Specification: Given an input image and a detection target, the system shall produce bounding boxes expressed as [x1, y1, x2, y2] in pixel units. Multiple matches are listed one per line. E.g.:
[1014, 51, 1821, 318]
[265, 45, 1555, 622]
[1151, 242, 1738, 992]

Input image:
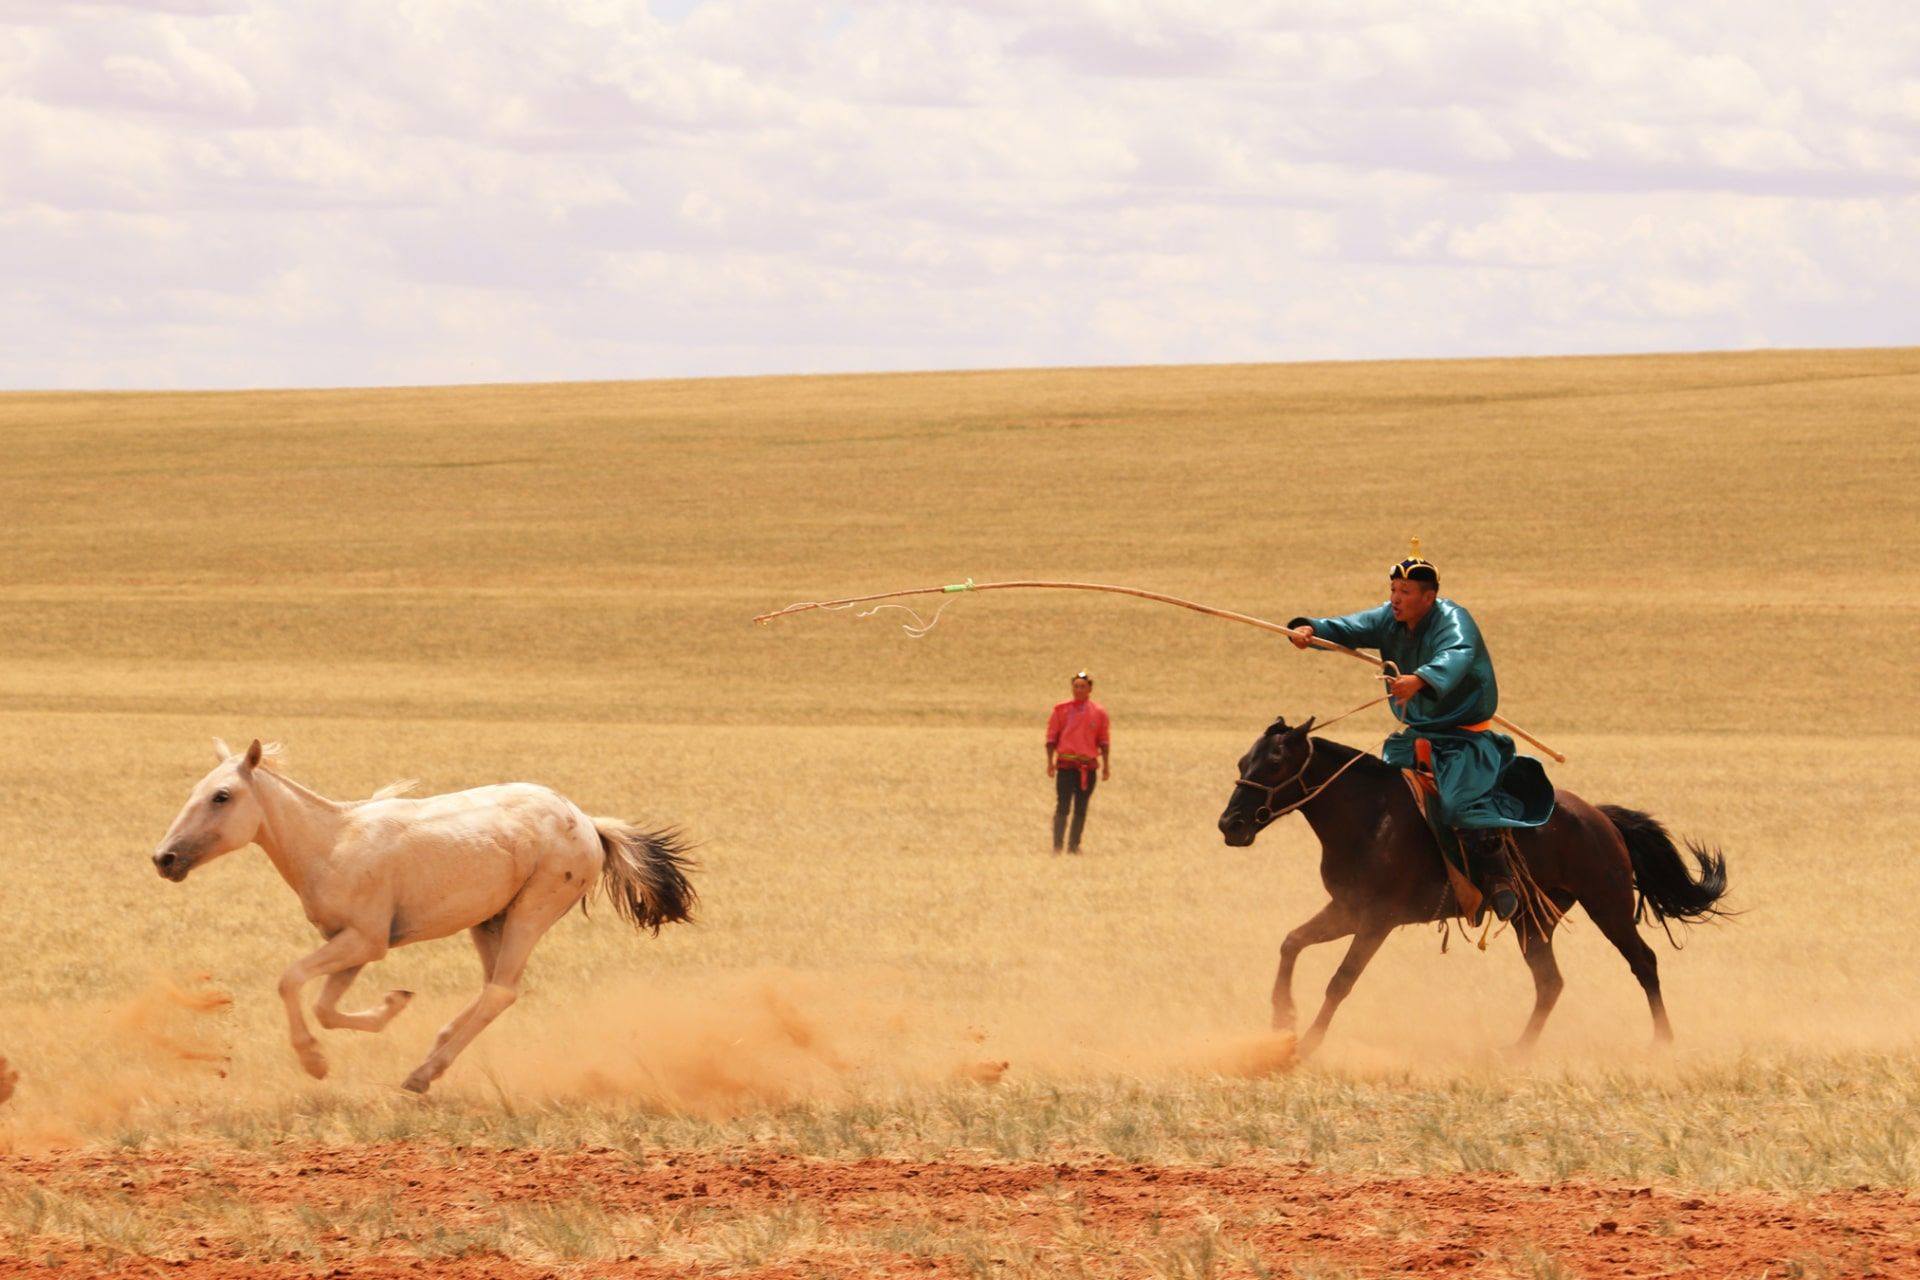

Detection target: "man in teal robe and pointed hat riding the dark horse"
[1286, 537, 1553, 923]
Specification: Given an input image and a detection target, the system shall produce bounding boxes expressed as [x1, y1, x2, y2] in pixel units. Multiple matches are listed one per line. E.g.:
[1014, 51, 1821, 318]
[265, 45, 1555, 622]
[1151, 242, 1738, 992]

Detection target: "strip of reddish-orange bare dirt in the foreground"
[0, 1144, 1920, 1280]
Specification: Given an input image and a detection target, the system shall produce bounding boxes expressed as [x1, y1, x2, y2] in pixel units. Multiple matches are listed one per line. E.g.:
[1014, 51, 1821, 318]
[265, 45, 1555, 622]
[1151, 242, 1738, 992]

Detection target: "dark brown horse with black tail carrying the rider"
[1219, 720, 1728, 1057]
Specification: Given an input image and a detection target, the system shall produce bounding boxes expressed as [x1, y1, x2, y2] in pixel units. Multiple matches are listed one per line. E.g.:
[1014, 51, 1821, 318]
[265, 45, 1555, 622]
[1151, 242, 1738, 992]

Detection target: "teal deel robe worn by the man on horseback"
[1286, 597, 1553, 827]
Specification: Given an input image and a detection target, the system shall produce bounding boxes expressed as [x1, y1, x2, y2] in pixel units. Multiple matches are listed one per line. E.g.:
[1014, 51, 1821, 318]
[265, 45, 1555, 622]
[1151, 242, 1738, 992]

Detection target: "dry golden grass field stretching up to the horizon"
[0, 349, 1920, 1274]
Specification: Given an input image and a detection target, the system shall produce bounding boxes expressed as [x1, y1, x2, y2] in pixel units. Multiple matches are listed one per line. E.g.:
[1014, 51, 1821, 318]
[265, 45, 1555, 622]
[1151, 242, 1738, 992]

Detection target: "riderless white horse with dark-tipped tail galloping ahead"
[154, 739, 695, 1094]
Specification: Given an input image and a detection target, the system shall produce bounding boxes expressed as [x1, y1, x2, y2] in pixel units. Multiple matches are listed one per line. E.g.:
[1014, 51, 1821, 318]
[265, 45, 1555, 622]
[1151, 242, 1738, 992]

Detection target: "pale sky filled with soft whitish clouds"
[0, 0, 1920, 390]
